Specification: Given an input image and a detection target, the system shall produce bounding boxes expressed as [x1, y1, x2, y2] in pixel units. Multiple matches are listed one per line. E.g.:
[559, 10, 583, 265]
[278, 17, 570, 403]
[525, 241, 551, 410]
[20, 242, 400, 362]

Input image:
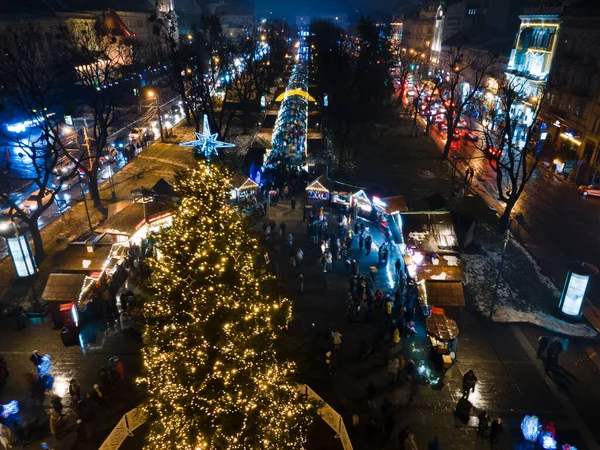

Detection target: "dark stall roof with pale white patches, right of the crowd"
[401, 211, 458, 253]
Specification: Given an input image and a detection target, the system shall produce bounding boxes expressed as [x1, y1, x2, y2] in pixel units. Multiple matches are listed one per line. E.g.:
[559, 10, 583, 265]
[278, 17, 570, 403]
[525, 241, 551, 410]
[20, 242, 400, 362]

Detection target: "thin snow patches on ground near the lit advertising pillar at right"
[462, 250, 596, 338]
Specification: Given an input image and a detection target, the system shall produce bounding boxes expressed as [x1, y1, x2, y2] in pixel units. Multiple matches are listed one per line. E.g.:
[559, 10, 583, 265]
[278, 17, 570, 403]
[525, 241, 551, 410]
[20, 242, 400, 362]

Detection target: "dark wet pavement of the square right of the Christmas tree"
[260, 203, 586, 450]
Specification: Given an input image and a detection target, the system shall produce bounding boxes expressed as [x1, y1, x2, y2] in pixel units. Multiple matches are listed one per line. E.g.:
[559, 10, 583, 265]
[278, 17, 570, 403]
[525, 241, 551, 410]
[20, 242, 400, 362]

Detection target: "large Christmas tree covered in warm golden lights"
[140, 165, 311, 450]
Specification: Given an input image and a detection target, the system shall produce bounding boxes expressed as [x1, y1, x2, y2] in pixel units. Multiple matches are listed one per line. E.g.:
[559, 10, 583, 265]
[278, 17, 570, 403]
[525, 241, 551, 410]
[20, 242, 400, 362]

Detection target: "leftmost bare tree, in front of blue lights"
[0, 25, 70, 263]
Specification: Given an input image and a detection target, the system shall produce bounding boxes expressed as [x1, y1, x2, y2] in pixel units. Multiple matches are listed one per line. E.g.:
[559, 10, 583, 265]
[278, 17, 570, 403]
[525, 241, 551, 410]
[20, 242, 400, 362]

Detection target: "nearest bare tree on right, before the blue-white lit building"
[476, 78, 548, 229]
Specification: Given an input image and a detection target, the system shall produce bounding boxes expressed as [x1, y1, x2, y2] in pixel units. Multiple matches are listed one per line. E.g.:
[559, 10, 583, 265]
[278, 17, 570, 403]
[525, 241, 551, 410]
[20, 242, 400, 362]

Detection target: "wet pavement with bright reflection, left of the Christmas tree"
[0, 317, 141, 450]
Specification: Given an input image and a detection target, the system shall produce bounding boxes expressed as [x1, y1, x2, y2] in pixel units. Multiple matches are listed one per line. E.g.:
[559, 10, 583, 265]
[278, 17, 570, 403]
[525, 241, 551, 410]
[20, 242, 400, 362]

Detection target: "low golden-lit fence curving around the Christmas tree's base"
[98, 384, 353, 450]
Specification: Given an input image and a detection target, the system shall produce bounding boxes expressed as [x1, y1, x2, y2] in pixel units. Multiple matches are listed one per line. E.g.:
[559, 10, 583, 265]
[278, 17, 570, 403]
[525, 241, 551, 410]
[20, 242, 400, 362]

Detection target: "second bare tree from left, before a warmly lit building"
[63, 21, 132, 215]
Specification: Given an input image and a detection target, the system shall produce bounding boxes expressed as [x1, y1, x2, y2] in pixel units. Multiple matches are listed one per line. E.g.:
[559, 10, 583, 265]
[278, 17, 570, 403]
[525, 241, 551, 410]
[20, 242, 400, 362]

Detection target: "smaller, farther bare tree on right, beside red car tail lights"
[439, 47, 497, 159]
